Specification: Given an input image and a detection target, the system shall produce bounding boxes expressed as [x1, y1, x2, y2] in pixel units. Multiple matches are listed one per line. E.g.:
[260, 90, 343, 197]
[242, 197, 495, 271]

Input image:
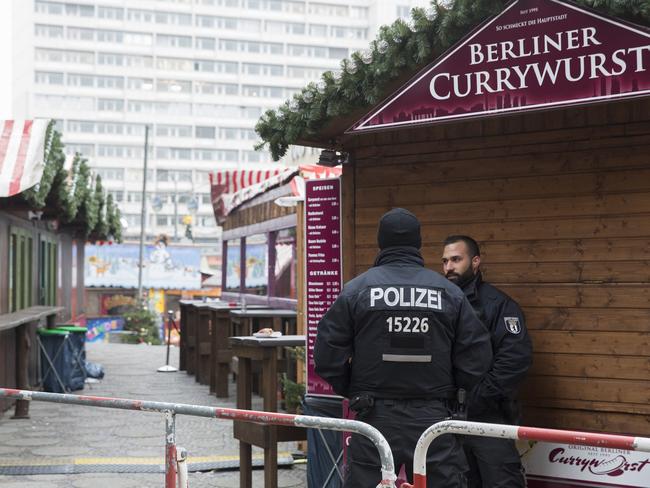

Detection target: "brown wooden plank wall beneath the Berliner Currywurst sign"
[350, 102, 650, 435]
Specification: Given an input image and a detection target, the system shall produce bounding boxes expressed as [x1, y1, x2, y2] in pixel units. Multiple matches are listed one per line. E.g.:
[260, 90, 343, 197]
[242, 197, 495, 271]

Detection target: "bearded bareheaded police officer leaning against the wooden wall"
[442, 235, 532, 488]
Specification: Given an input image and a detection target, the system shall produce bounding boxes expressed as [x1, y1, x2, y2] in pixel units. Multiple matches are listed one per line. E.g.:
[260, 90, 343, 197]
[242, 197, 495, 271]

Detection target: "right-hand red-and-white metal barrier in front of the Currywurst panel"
[401, 420, 650, 488]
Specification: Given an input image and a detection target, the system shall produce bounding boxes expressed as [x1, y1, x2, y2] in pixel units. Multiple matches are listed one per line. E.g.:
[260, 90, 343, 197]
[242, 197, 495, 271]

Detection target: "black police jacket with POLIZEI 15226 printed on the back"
[314, 247, 492, 399]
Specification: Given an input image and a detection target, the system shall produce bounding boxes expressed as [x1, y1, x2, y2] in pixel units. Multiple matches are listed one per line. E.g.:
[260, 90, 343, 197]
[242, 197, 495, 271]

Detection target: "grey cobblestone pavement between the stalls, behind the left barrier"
[0, 343, 307, 488]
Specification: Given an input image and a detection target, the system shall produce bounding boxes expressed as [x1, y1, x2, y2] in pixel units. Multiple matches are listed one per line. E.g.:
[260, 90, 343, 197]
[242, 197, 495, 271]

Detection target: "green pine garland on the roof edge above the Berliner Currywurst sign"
[255, 0, 650, 161]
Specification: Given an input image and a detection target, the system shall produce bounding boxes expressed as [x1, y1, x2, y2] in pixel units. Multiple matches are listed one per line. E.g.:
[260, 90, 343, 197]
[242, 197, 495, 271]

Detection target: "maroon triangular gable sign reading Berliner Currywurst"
[349, 0, 650, 132]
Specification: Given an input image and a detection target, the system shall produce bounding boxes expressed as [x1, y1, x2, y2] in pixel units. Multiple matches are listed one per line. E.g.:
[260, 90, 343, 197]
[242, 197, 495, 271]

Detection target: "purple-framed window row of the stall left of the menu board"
[223, 227, 297, 300]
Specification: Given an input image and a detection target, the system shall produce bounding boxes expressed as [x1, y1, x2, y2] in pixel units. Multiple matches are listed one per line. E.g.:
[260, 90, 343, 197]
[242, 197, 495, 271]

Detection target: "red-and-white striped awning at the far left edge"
[0, 119, 48, 198]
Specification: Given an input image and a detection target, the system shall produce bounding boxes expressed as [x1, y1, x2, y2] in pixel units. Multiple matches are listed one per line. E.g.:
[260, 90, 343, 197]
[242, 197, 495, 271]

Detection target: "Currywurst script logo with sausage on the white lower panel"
[548, 446, 650, 477]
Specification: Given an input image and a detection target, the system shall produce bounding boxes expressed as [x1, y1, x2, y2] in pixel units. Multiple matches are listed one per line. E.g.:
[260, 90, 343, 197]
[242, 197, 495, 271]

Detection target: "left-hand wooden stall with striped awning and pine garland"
[0, 120, 120, 417]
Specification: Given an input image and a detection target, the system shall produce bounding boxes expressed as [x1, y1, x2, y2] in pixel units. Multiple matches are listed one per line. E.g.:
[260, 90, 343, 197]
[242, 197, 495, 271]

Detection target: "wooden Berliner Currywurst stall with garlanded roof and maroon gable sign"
[258, 0, 650, 435]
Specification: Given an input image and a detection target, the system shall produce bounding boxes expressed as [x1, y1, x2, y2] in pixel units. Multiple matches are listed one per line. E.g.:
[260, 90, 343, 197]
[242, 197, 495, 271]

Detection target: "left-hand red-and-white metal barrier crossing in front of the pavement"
[0, 388, 397, 488]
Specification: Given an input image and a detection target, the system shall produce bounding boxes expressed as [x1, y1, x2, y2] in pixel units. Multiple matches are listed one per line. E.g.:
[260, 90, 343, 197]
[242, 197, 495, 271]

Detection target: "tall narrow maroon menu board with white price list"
[305, 178, 342, 396]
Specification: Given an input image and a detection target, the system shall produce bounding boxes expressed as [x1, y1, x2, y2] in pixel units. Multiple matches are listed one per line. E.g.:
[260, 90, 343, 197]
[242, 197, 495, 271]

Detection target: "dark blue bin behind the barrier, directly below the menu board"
[303, 395, 343, 488]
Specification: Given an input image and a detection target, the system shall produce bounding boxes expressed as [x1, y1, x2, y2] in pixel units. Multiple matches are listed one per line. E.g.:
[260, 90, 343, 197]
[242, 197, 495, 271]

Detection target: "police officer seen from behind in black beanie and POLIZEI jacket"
[314, 208, 492, 488]
